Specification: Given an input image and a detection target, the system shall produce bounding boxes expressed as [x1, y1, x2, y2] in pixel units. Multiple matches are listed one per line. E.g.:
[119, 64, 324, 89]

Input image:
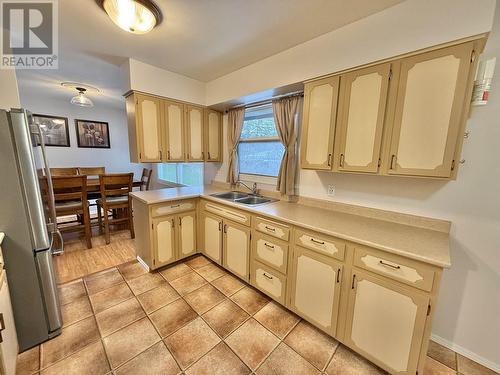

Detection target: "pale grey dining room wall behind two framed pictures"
[19, 86, 146, 179]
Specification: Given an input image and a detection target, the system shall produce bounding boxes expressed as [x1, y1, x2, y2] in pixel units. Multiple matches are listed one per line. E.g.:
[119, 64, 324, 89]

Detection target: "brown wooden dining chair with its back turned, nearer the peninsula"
[97, 173, 135, 244]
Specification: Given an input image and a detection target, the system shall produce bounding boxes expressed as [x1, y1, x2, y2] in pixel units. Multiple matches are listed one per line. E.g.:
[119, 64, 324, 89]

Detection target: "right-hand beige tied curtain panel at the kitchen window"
[273, 96, 301, 196]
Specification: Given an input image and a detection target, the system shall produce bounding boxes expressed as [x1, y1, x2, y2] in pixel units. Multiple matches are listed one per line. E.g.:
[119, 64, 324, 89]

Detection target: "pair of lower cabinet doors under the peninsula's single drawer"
[152, 211, 196, 268]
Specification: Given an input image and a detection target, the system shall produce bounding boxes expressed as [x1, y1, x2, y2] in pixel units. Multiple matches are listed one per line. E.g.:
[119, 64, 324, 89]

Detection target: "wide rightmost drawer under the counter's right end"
[354, 247, 436, 291]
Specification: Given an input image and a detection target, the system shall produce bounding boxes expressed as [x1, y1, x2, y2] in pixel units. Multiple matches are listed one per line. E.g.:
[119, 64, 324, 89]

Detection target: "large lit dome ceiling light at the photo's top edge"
[96, 0, 163, 34]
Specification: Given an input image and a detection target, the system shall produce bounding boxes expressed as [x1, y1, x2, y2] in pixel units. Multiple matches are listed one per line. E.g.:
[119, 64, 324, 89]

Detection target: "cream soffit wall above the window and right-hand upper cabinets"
[206, 0, 495, 105]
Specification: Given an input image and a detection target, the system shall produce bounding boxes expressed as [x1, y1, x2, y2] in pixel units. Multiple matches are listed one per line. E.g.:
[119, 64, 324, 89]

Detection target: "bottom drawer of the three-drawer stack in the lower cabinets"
[251, 261, 286, 304]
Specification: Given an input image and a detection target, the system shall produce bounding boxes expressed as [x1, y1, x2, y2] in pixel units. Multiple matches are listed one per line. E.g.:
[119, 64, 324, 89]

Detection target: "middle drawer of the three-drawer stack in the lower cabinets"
[252, 232, 288, 275]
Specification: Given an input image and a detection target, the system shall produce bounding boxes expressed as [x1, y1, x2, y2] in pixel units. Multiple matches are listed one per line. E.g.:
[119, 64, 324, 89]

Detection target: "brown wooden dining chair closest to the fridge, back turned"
[52, 175, 92, 249]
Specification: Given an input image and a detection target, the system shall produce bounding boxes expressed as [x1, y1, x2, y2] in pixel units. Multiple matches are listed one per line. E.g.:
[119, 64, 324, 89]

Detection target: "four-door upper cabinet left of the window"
[126, 92, 222, 163]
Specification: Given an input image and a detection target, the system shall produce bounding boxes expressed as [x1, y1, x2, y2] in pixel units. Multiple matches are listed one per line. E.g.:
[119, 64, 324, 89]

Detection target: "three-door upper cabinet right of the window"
[301, 39, 484, 178]
